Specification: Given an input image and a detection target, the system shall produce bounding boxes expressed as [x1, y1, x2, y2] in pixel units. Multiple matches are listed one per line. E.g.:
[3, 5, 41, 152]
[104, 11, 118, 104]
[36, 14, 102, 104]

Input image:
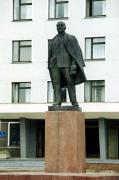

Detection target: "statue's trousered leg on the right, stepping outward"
[62, 68, 78, 106]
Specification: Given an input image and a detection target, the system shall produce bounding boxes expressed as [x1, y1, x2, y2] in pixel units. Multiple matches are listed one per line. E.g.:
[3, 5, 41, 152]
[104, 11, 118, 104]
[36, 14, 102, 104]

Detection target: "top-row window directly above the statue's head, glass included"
[49, 0, 68, 18]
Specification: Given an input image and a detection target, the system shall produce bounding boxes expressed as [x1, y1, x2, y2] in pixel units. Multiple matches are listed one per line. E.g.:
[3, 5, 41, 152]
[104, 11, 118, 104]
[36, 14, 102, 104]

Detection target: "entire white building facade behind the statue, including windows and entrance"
[0, 0, 119, 163]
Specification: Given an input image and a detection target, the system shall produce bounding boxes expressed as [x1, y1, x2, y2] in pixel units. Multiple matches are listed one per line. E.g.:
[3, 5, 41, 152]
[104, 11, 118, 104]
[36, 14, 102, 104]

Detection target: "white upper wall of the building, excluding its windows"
[0, 0, 119, 106]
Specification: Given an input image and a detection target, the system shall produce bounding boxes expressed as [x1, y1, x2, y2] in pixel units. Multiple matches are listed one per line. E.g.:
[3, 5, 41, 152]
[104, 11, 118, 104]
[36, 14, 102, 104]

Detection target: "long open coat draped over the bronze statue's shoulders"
[48, 33, 86, 87]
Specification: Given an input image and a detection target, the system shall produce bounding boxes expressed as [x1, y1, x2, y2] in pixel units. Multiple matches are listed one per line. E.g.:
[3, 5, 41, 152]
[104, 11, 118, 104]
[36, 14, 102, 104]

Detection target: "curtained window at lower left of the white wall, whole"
[12, 82, 31, 103]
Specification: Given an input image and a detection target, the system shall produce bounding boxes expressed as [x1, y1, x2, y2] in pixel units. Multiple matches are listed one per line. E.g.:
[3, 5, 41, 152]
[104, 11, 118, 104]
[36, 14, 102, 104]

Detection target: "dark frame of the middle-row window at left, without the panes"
[12, 40, 32, 64]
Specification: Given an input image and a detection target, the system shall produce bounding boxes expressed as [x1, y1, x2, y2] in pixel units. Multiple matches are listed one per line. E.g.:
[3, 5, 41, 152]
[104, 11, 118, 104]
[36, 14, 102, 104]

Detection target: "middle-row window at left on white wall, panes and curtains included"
[12, 41, 31, 63]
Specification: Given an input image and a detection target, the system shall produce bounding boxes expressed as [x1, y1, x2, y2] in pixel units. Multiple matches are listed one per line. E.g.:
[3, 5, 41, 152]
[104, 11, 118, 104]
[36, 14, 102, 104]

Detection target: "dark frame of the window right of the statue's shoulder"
[85, 36, 106, 61]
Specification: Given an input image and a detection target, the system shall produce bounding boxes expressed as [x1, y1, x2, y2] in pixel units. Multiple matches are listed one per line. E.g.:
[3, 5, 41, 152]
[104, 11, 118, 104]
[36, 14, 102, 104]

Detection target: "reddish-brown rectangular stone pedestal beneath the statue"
[45, 111, 85, 173]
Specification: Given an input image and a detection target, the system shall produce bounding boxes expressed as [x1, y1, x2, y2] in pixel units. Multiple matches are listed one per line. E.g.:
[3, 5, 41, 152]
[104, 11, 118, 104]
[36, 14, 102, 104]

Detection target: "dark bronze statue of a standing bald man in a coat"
[48, 21, 86, 106]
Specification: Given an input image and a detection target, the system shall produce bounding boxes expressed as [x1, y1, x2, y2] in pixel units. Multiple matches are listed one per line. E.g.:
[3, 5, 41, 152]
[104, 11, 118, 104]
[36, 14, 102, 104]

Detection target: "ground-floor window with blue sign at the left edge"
[0, 119, 20, 159]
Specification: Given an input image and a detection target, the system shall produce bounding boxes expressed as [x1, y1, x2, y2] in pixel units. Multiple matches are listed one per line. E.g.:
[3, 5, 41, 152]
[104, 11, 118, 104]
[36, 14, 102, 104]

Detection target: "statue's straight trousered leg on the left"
[52, 67, 61, 105]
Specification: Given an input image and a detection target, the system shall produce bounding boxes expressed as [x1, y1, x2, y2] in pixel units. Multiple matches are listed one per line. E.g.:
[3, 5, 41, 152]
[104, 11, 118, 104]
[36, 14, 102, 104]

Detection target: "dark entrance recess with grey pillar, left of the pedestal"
[20, 119, 45, 158]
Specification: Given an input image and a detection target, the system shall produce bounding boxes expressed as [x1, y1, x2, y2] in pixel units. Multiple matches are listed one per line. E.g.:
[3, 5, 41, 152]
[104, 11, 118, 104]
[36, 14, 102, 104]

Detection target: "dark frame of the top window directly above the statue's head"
[48, 0, 69, 20]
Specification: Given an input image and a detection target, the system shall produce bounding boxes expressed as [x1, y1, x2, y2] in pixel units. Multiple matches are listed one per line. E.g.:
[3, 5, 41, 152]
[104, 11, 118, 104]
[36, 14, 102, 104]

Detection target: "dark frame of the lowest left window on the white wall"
[12, 81, 31, 104]
